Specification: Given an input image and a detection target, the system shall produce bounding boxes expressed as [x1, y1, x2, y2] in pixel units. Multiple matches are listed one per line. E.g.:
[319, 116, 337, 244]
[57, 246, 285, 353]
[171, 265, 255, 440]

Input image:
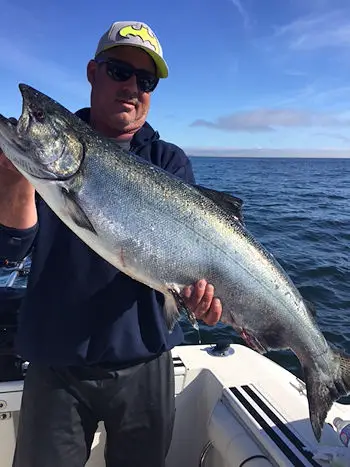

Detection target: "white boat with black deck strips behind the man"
[0, 266, 350, 467]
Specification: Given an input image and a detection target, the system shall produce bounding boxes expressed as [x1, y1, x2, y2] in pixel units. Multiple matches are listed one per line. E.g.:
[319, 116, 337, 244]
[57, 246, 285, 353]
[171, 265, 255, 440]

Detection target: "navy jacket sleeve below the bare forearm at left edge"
[0, 223, 38, 261]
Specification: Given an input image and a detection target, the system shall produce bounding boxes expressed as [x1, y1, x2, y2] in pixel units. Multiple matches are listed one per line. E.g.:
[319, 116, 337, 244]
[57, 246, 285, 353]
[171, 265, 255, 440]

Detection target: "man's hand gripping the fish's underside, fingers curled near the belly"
[182, 279, 222, 326]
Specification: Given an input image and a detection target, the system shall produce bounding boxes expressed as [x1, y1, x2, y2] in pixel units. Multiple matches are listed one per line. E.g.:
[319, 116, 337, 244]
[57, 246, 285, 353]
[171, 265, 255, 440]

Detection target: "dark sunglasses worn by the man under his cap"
[95, 57, 159, 92]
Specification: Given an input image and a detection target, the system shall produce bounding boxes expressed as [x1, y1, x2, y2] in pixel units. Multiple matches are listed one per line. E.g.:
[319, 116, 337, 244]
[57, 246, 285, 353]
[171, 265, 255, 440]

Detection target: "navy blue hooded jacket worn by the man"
[0, 109, 194, 368]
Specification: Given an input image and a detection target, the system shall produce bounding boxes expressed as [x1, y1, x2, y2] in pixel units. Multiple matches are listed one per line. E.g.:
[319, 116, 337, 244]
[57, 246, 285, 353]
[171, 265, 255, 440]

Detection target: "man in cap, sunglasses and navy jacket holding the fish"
[0, 22, 221, 467]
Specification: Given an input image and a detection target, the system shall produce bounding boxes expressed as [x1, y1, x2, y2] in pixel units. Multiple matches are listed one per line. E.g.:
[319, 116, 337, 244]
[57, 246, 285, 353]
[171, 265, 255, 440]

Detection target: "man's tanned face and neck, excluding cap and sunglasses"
[87, 46, 156, 139]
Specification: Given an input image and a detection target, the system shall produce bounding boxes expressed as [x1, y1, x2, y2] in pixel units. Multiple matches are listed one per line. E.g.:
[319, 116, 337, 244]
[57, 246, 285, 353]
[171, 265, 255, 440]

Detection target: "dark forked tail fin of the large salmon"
[303, 349, 350, 441]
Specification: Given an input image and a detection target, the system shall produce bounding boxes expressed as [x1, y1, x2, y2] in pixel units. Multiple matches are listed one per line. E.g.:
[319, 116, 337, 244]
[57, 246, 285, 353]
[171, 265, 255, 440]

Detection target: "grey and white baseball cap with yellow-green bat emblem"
[95, 21, 168, 78]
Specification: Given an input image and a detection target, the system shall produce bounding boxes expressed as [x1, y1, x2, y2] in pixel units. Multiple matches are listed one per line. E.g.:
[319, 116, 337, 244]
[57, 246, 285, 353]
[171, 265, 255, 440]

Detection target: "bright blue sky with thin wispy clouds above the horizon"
[0, 0, 350, 155]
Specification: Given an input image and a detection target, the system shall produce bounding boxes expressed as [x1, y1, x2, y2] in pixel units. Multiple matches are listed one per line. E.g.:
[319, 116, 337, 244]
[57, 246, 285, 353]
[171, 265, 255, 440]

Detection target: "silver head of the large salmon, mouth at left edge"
[0, 84, 84, 180]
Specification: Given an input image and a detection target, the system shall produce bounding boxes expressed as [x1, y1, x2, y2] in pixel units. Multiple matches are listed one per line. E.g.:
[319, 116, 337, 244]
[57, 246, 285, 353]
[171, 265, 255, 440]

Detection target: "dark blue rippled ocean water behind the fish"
[181, 157, 350, 376]
